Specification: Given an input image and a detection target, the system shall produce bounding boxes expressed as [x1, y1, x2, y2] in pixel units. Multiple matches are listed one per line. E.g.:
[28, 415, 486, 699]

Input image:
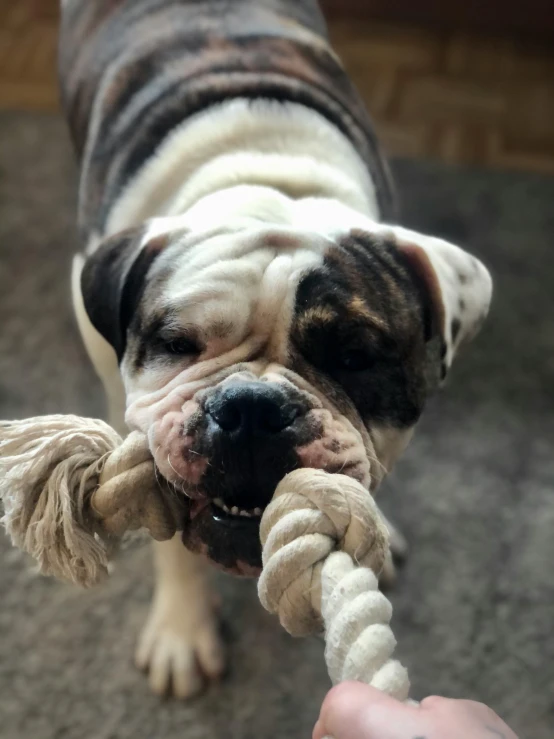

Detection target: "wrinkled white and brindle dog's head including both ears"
[82, 219, 491, 574]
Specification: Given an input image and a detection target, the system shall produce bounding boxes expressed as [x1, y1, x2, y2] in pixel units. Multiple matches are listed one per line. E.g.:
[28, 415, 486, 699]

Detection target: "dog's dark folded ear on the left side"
[81, 226, 168, 362]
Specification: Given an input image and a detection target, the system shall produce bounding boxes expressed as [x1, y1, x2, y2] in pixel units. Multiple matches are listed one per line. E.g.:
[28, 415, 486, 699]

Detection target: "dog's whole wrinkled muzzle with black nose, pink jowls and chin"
[145, 371, 372, 576]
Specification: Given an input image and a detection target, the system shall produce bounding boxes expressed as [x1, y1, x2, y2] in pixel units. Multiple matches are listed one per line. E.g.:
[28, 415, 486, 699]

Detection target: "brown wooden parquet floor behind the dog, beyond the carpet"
[0, 0, 554, 173]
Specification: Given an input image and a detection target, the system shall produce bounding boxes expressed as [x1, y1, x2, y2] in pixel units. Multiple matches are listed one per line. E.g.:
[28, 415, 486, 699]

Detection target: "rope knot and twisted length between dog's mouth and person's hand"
[258, 469, 409, 700]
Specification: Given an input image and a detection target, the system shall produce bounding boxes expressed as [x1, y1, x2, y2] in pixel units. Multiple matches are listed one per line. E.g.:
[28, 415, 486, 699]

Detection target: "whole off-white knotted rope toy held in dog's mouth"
[0, 415, 410, 700]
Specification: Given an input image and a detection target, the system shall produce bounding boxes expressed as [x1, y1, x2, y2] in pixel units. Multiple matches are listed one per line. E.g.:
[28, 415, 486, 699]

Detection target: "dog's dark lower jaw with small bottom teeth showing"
[182, 498, 264, 577]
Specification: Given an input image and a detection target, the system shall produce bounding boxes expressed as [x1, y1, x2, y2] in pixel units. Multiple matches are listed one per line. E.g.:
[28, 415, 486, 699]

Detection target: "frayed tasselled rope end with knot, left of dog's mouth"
[0, 415, 176, 587]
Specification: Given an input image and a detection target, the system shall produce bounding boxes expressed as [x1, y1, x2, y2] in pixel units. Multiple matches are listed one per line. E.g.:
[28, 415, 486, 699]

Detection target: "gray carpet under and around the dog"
[0, 114, 554, 739]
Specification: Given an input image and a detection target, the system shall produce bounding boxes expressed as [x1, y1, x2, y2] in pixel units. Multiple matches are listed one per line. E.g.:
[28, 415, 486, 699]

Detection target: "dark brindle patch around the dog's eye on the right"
[291, 232, 426, 428]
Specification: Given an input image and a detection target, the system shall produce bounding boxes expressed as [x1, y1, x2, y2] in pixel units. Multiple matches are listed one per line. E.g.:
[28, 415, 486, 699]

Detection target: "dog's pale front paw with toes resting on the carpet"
[135, 597, 225, 700]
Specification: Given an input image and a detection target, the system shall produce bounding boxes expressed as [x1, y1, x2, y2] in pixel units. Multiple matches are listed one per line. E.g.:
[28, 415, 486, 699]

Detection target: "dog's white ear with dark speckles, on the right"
[388, 226, 492, 379]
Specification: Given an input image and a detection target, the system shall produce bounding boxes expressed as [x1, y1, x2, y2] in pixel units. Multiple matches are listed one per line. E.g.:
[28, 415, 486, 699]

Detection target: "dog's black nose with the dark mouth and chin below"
[183, 380, 309, 574]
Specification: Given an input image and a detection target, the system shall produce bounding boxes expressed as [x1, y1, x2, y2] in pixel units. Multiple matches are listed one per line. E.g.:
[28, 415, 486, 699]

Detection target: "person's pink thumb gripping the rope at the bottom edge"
[313, 682, 425, 739]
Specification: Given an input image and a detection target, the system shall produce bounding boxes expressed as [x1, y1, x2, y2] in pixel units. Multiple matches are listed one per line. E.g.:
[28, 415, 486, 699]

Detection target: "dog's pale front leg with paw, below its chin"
[136, 534, 225, 698]
